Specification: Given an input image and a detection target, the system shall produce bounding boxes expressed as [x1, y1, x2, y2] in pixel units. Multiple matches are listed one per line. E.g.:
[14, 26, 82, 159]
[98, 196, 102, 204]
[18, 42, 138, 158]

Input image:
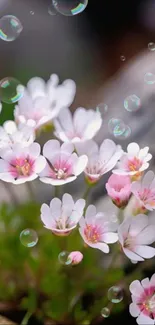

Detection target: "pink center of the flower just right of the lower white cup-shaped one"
[84, 224, 101, 244]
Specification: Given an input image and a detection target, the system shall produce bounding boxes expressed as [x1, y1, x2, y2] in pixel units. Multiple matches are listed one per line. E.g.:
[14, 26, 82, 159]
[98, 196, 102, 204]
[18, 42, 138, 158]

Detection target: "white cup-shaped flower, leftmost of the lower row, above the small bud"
[41, 193, 85, 236]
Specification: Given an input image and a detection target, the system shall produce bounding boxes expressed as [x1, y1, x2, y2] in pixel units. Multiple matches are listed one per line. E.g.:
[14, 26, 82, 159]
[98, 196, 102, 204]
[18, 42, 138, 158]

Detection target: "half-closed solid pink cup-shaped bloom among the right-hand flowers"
[105, 174, 131, 208]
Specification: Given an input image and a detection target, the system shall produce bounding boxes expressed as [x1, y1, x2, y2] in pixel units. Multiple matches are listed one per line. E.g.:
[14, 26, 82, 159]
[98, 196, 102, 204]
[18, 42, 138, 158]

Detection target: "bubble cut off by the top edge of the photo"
[52, 0, 88, 16]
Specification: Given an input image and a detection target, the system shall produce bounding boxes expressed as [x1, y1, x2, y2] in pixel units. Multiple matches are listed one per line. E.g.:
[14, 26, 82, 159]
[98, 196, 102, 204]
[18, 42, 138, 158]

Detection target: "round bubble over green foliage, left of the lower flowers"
[20, 229, 38, 247]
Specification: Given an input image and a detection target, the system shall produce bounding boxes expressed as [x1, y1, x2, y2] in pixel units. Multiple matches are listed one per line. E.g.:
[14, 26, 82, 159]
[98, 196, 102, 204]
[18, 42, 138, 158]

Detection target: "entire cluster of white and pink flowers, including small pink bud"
[0, 75, 155, 324]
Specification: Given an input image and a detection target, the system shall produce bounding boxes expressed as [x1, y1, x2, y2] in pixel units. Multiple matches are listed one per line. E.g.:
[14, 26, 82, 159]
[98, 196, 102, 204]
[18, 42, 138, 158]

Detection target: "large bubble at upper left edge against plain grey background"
[0, 15, 23, 42]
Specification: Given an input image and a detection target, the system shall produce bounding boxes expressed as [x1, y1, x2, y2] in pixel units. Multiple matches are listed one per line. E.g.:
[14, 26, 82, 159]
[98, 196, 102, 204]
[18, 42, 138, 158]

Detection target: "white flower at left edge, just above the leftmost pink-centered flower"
[0, 121, 35, 149]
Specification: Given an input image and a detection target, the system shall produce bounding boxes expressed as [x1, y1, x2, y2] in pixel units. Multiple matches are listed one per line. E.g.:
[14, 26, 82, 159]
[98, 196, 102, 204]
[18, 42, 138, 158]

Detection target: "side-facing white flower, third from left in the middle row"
[75, 139, 123, 183]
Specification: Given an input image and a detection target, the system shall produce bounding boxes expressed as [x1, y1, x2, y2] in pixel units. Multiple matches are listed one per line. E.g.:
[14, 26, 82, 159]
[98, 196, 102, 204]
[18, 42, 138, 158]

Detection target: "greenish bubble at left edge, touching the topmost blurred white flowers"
[0, 77, 24, 104]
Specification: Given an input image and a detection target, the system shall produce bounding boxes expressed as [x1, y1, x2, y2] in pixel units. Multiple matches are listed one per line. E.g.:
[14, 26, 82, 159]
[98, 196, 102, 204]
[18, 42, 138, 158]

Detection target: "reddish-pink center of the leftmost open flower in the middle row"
[10, 158, 33, 178]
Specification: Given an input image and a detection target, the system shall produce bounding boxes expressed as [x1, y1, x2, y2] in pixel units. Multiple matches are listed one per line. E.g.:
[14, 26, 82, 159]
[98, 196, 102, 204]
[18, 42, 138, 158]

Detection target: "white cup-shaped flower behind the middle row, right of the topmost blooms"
[54, 107, 102, 143]
